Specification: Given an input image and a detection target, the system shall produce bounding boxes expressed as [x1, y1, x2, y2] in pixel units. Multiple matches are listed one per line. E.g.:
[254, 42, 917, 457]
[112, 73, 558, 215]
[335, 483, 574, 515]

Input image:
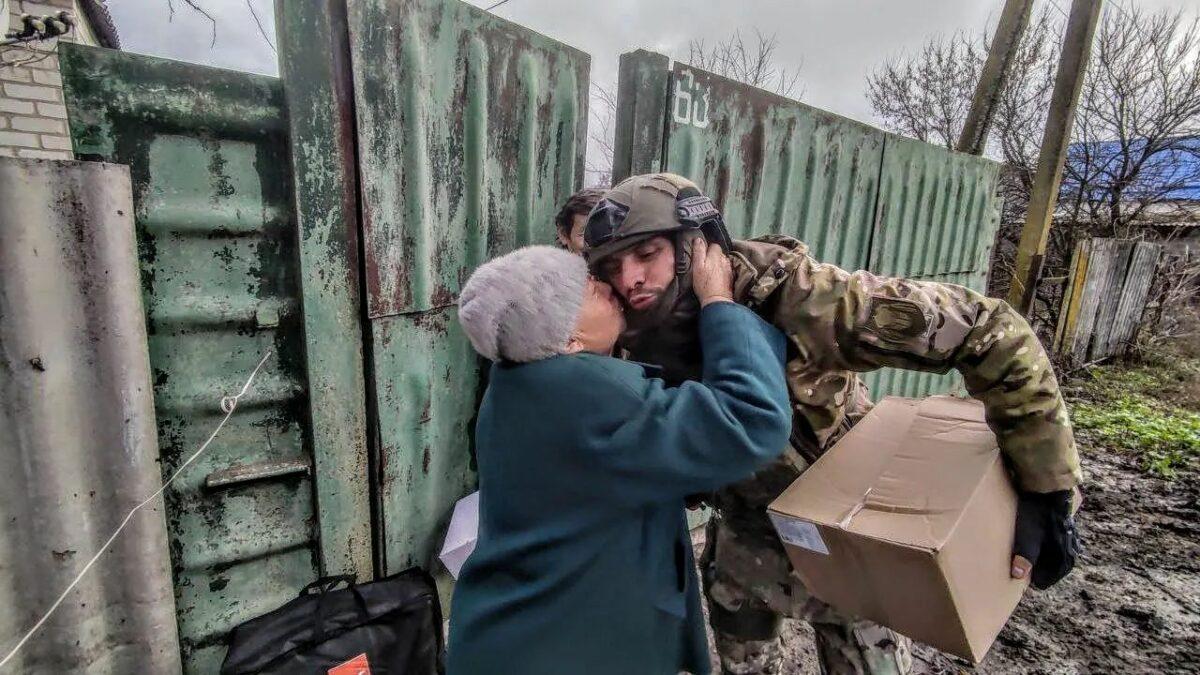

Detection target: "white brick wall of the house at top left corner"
[0, 0, 97, 160]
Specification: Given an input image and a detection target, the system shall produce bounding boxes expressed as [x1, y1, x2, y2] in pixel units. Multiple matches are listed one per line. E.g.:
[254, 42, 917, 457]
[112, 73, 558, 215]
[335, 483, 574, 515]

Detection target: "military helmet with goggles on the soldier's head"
[583, 173, 731, 267]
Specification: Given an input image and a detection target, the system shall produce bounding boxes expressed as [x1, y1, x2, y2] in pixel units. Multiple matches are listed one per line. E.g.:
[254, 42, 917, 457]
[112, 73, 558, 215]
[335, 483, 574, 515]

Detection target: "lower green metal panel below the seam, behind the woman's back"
[372, 307, 481, 573]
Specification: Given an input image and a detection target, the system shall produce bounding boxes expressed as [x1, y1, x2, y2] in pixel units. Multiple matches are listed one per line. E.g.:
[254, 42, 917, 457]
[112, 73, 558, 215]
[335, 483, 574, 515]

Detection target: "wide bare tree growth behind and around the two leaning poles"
[866, 5, 1200, 325]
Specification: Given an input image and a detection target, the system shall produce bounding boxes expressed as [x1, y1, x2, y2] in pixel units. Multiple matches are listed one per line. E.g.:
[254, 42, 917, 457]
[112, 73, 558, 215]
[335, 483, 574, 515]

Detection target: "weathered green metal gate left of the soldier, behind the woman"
[61, 0, 589, 673]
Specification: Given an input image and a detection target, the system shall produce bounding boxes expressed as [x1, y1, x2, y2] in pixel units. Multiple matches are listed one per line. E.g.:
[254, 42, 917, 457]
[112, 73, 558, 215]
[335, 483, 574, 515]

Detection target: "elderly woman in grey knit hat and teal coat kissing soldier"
[449, 240, 791, 675]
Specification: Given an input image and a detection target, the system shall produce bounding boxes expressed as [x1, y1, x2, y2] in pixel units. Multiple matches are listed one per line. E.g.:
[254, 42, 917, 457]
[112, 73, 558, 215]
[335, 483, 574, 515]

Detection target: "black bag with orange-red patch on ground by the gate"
[221, 567, 443, 675]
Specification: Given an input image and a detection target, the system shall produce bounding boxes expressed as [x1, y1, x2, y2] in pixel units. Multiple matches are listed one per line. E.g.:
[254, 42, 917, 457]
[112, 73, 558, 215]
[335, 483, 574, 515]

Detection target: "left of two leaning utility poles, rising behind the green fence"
[956, 0, 1033, 155]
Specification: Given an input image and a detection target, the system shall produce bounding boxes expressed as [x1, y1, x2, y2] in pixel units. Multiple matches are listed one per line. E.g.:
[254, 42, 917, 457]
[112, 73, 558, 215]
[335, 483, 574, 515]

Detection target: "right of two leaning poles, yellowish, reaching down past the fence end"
[1008, 0, 1103, 316]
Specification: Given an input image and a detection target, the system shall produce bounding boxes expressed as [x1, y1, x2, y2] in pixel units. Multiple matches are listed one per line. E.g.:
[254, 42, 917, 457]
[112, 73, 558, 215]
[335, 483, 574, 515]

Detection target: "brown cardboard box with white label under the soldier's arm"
[769, 396, 1027, 663]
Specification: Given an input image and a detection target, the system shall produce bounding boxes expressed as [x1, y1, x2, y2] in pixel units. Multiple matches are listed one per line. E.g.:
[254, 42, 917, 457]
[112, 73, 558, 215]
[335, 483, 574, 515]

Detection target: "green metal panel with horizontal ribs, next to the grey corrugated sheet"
[60, 44, 318, 674]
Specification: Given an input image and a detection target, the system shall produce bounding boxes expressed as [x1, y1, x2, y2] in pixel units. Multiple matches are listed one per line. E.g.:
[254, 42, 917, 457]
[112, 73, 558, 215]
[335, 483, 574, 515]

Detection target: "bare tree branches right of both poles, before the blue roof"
[1064, 8, 1200, 238]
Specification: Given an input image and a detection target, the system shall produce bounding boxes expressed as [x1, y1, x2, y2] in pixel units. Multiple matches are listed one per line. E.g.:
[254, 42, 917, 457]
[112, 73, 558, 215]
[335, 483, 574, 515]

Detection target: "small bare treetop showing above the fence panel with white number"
[688, 29, 804, 97]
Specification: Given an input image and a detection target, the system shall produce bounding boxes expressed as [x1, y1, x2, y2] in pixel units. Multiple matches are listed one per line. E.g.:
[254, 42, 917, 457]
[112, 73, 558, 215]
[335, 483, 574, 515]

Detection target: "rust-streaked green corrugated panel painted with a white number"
[665, 64, 884, 269]
